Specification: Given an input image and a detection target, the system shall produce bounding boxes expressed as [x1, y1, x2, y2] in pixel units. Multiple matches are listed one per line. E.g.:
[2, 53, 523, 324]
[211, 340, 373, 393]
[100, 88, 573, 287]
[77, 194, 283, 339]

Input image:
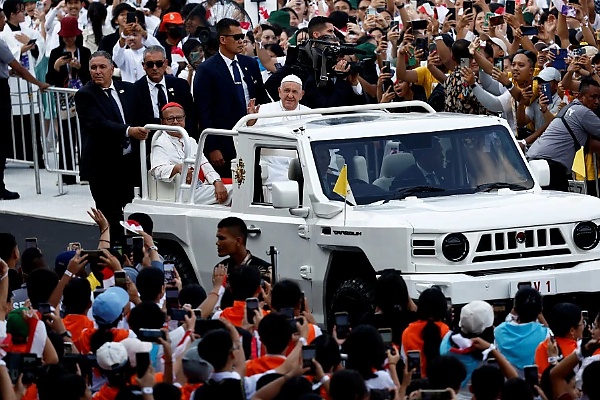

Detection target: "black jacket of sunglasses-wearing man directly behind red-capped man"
[133, 75, 198, 139]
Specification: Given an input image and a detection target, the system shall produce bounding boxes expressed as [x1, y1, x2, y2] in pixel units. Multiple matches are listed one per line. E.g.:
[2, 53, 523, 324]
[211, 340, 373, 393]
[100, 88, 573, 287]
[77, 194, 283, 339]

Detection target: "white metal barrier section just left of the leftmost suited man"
[39, 87, 81, 195]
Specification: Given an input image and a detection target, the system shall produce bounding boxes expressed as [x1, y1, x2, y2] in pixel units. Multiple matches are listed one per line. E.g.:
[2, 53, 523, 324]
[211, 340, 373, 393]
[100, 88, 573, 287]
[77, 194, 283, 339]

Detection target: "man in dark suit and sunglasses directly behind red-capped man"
[133, 46, 198, 138]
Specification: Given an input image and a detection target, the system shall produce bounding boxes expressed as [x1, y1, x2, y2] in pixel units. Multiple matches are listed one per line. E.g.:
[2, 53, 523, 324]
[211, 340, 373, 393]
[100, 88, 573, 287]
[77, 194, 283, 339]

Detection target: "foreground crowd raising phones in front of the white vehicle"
[0, 209, 600, 400]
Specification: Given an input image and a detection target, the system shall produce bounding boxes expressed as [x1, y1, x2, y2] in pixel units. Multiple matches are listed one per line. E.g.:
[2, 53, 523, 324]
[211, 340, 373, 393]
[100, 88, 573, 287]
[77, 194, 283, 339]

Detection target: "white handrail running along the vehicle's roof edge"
[232, 100, 436, 130]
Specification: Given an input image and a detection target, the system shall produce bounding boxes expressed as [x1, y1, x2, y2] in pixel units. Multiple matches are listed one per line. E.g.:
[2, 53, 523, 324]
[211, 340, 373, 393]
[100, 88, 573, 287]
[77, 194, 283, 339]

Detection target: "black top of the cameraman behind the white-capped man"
[300, 74, 367, 108]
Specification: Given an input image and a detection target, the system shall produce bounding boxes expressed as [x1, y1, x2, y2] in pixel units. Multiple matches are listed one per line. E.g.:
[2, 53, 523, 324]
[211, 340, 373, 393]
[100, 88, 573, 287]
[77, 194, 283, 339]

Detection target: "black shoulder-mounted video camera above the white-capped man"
[298, 39, 368, 87]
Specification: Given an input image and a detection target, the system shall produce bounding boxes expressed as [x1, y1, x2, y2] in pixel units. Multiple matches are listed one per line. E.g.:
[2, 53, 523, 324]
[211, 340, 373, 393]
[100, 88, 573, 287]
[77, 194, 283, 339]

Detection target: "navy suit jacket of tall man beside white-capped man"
[194, 53, 270, 161]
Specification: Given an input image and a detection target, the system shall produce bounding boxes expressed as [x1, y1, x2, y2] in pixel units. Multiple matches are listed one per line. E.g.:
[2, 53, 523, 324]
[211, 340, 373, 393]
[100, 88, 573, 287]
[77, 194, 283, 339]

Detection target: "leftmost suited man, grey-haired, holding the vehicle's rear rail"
[75, 51, 148, 243]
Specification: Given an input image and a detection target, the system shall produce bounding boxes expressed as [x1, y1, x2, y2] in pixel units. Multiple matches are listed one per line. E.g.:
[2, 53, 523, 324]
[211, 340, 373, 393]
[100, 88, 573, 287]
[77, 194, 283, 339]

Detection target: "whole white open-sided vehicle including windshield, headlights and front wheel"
[125, 102, 600, 322]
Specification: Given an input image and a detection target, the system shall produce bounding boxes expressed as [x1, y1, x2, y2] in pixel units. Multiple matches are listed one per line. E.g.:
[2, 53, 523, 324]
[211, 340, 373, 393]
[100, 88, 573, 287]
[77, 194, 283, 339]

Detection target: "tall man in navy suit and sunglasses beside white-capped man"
[194, 18, 270, 177]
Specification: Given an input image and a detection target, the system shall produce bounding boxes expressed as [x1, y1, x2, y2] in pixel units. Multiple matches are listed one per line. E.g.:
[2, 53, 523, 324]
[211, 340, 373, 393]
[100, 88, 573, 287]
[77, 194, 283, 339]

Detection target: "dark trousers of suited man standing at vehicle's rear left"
[89, 154, 139, 245]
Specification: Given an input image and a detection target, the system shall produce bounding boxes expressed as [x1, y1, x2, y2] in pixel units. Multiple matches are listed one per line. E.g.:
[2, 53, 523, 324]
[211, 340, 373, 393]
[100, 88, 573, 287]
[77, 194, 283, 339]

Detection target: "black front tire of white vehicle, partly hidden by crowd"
[327, 278, 375, 331]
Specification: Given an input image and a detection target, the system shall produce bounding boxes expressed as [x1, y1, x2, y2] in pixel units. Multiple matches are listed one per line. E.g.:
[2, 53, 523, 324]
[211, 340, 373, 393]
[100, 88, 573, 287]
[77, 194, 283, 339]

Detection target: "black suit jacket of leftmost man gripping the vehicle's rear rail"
[75, 80, 139, 183]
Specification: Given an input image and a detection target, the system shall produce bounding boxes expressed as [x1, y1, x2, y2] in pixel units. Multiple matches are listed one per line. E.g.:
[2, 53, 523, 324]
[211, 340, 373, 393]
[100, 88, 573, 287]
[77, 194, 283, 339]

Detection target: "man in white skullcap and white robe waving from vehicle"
[247, 75, 314, 126]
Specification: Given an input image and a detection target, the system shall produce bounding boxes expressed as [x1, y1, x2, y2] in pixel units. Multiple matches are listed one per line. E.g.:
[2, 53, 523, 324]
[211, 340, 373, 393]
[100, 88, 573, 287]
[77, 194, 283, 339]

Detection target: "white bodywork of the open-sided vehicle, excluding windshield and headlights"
[125, 102, 600, 321]
